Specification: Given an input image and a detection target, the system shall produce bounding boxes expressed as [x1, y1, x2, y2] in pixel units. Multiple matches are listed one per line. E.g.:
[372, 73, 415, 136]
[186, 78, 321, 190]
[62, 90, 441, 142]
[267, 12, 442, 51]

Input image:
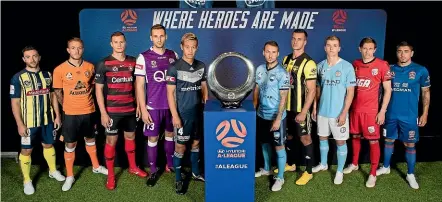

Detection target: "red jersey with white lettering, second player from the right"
[351, 58, 391, 113]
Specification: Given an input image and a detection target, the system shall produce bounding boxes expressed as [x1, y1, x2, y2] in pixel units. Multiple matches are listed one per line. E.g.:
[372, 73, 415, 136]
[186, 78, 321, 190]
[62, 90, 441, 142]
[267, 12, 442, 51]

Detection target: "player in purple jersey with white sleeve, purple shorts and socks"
[135, 24, 178, 186]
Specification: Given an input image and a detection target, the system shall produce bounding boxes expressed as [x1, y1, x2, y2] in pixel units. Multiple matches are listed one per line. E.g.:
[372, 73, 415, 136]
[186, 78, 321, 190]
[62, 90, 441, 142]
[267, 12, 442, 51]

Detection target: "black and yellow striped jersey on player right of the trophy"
[282, 53, 317, 112]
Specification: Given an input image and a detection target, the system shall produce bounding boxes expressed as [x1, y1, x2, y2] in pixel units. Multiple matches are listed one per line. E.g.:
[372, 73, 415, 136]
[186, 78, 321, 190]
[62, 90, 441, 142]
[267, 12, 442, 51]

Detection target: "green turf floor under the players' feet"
[1, 159, 442, 202]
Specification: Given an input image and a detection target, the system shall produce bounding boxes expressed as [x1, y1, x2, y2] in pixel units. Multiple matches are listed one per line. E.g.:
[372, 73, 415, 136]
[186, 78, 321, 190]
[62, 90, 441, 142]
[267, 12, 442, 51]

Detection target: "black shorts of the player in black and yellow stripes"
[287, 111, 312, 136]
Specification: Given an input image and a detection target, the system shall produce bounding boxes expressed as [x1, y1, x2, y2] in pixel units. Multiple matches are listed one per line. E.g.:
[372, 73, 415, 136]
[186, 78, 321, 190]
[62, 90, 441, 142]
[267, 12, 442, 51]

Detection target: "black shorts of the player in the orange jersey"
[62, 113, 97, 143]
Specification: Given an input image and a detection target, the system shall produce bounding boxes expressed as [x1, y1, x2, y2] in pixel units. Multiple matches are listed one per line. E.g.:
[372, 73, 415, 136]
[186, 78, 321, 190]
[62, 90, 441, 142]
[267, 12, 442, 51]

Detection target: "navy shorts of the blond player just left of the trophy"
[175, 113, 203, 144]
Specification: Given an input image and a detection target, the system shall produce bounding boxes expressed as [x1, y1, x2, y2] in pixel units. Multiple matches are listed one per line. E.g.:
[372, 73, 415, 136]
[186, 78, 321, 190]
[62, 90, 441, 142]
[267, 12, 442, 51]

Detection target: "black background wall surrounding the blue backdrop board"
[1, 1, 442, 167]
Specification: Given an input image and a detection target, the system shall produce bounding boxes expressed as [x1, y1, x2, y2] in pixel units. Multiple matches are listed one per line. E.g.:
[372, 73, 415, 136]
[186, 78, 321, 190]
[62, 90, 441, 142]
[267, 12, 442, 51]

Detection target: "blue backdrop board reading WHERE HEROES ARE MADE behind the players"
[80, 8, 387, 97]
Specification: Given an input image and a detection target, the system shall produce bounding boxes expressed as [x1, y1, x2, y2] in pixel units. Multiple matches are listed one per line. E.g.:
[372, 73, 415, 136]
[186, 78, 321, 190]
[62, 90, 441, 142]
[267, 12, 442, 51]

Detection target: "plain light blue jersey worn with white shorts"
[317, 58, 356, 118]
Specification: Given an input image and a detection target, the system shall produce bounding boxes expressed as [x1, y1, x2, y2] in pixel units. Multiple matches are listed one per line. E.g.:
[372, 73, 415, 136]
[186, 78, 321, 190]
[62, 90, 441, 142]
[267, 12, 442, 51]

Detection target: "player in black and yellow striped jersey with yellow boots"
[275, 29, 316, 185]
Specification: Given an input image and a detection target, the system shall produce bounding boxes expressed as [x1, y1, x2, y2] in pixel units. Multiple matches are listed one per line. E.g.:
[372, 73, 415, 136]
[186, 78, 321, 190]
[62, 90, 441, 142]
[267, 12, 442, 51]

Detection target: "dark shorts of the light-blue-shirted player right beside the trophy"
[256, 116, 287, 146]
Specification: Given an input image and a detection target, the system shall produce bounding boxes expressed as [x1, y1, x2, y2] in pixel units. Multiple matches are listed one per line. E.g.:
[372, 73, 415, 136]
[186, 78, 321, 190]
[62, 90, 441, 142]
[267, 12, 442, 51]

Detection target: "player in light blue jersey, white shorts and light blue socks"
[312, 36, 356, 184]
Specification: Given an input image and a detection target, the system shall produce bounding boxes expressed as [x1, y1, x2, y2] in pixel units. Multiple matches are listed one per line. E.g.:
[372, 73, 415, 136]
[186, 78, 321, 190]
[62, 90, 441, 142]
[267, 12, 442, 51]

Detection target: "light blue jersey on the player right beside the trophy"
[256, 64, 290, 120]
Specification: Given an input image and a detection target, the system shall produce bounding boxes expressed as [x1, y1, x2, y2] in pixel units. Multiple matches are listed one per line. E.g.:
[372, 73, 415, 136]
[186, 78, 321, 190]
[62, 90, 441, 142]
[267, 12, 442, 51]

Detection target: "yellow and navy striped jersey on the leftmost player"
[9, 69, 54, 128]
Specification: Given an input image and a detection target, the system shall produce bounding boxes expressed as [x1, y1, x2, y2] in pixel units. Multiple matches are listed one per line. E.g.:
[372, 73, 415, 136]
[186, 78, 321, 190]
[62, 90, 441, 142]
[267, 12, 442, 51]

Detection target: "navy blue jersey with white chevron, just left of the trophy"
[166, 58, 207, 114]
